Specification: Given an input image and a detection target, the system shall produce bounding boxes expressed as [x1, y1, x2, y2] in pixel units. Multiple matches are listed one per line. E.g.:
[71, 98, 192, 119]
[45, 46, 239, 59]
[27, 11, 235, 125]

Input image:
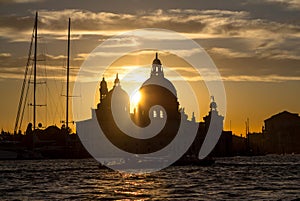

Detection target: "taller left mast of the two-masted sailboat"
[33, 12, 38, 129]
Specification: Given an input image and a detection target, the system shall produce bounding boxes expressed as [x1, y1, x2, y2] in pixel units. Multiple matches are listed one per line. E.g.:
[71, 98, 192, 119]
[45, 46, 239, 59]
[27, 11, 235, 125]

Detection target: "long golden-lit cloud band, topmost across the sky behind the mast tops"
[1, 9, 300, 41]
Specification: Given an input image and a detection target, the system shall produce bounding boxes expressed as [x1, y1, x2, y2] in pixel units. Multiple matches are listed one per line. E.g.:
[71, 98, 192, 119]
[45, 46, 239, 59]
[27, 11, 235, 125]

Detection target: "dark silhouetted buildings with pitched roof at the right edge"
[232, 111, 300, 155]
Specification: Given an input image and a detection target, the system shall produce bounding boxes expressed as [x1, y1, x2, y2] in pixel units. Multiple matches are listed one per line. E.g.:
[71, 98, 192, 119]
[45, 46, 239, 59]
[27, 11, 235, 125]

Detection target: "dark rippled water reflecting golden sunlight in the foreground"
[0, 155, 300, 200]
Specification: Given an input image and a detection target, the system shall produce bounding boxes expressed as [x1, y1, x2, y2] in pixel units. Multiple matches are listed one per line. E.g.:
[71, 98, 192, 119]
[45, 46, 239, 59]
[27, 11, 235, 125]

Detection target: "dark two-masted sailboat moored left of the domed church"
[0, 12, 89, 159]
